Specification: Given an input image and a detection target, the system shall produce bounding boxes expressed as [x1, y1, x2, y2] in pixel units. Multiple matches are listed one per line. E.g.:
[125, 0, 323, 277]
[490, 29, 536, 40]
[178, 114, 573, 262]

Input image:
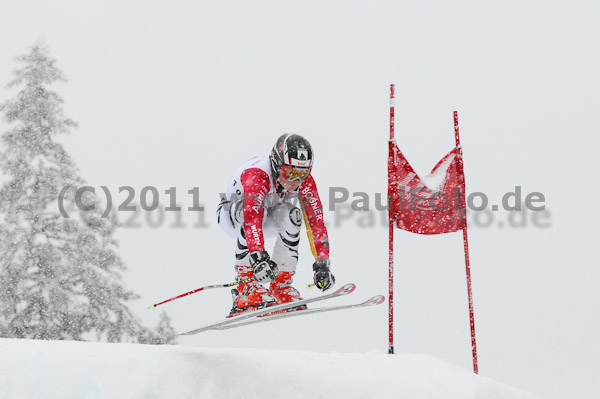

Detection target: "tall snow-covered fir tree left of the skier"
[0, 44, 175, 343]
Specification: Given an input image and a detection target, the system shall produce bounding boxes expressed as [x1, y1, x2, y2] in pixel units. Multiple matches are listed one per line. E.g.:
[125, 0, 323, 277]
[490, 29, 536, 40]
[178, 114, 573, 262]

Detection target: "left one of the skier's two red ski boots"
[227, 266, 277, 317]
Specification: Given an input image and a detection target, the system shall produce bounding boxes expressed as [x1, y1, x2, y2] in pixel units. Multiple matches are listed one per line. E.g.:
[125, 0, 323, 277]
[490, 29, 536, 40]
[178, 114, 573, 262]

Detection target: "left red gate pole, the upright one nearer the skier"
[388, 84, 396, 355]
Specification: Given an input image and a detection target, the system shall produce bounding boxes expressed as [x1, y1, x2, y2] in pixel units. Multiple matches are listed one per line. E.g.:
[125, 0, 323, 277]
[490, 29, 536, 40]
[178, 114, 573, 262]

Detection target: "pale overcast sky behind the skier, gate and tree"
[0, 1, 600, 399]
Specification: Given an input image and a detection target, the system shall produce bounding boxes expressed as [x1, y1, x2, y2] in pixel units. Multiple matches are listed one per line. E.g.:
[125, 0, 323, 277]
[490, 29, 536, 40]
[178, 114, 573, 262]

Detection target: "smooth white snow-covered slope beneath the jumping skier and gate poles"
[0, 339, 534, 399]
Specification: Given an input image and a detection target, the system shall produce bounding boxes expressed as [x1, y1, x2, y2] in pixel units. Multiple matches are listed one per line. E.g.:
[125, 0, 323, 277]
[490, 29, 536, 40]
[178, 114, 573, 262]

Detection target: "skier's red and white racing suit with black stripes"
[218, 157, 329, 273]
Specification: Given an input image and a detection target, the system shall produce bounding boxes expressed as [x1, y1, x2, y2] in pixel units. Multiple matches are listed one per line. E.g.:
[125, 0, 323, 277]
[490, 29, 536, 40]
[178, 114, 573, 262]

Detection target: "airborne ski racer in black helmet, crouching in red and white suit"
[217, 134, 335, 315]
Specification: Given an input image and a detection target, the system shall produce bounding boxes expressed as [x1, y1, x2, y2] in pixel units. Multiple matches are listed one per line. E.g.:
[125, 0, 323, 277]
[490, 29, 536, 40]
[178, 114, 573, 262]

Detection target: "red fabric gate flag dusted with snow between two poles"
[390, 145, 466, 234]
